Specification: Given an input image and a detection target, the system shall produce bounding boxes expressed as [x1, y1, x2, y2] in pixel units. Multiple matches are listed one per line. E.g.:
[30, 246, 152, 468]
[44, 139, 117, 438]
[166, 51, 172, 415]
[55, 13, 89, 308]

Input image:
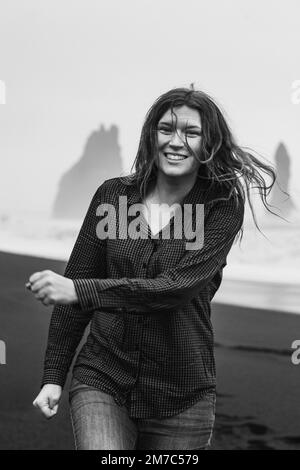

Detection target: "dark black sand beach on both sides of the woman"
[0, 253, 300, 450]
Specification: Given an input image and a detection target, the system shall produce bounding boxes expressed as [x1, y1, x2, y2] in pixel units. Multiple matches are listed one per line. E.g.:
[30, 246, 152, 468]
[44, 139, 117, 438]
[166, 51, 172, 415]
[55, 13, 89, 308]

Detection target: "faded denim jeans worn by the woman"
[69, 377, 216, 450]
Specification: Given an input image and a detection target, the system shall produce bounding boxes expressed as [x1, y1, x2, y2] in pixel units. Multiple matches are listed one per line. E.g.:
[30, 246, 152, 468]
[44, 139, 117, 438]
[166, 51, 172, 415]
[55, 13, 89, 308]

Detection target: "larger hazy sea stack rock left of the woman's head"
[52, 125, 122, 219]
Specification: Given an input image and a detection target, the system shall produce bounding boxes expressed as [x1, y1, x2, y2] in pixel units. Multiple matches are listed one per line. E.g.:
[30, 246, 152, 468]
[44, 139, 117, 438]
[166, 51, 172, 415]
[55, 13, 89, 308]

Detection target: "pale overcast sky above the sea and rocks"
[0, 0, 300, 214]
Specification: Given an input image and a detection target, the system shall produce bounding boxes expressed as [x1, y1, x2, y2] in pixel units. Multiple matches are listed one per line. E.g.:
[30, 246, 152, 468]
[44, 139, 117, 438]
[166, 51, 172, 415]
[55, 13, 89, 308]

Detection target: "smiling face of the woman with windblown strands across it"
[157, 105, 201, 176]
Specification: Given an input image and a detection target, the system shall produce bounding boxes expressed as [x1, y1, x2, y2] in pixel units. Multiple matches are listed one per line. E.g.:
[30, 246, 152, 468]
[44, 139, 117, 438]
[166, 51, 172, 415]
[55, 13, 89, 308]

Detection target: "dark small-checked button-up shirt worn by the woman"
[42, 178, 244, 418]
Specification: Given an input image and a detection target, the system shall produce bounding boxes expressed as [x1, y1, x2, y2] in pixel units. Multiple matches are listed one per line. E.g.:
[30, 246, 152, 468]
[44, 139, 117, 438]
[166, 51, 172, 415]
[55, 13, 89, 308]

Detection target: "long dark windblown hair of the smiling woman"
[122, 85, 288, 241]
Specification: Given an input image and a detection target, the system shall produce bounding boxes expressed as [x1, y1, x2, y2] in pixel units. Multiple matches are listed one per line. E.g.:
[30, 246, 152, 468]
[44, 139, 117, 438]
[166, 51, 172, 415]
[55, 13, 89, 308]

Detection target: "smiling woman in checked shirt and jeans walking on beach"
[29, 88, 282, 450]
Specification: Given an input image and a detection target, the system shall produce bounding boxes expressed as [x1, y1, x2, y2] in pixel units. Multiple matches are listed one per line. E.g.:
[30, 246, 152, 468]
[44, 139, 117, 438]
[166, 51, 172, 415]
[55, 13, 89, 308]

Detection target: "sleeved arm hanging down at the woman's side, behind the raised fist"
[42, 182, 106, 387]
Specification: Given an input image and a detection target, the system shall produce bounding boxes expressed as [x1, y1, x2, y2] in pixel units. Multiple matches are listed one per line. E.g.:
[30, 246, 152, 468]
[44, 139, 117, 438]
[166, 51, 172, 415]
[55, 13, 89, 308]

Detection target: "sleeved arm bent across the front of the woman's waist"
[73, 193, 244, 313]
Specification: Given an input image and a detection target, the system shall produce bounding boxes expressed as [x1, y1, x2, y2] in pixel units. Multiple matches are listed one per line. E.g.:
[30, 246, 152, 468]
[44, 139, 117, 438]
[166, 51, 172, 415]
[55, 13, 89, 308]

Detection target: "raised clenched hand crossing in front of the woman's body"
[26, 269, 78, 305]
